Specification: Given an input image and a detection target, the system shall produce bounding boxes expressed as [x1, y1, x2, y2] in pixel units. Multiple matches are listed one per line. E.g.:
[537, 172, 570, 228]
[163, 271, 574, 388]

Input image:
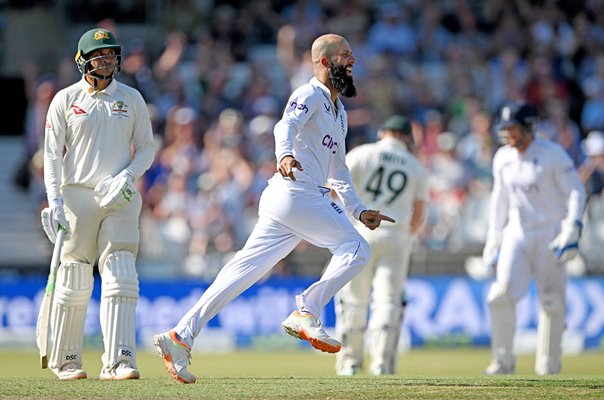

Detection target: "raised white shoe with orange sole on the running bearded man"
[281, 310, 342, 353]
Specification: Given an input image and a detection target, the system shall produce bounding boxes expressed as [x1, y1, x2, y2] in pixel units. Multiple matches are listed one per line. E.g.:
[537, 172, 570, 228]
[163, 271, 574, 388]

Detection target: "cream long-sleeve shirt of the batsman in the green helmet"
[44, 77, 155, 202]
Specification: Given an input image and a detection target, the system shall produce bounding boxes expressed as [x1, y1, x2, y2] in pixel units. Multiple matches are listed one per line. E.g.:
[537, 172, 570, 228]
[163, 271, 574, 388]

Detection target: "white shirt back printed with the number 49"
[346, 138, 427, 230]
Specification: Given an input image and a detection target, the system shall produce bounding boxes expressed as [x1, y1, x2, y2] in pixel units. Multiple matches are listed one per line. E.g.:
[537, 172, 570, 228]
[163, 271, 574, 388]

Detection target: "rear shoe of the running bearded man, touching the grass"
[153, 330, 197, 383]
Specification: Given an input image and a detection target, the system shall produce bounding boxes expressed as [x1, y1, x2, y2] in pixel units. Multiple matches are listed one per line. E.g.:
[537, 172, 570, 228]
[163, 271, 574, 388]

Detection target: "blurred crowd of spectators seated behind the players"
[16, 0, 604, 278]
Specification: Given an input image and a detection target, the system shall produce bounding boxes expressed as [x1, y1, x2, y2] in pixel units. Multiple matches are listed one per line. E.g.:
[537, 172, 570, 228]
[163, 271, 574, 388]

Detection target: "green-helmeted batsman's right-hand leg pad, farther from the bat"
[100, 251, 138, 369]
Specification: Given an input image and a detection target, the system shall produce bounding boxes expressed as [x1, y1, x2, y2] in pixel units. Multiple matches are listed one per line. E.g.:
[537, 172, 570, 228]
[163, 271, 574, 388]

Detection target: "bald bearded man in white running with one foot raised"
[154, 34, 394, 383]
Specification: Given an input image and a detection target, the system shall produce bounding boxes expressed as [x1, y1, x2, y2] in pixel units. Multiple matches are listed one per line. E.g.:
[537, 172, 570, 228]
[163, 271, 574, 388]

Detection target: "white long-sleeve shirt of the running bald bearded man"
[274, 78, 367, 219]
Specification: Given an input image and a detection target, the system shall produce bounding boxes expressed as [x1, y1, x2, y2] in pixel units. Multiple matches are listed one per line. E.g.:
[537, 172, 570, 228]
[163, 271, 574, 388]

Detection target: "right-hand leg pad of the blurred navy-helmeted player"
[535, 293, 565, 375]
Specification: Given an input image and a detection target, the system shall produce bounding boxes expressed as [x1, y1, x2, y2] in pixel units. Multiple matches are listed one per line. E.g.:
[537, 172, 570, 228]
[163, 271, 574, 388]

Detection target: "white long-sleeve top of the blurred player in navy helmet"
[488, 137, 585, 235]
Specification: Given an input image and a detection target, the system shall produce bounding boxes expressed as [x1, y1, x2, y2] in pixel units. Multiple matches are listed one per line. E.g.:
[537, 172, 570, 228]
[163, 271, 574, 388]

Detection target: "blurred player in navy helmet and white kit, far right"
[483, 102, 585, 375]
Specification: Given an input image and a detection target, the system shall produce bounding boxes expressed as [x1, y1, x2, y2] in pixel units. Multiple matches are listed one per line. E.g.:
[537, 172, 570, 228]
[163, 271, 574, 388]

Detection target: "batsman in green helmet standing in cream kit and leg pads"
[42, 29, 155, 380]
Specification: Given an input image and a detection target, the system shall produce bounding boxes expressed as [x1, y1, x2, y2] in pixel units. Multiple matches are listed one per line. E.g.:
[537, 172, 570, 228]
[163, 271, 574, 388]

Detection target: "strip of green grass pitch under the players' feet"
[0, 348, 604, 400]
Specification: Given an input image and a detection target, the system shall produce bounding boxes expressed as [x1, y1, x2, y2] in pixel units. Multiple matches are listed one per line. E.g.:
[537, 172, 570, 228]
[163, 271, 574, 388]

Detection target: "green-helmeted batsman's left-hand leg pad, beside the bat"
[49, 262, 94, 373]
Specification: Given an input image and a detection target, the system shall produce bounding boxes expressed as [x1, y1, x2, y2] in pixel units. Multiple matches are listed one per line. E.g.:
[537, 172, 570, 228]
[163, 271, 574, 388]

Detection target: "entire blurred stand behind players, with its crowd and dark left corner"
[0, 0, 604, 280]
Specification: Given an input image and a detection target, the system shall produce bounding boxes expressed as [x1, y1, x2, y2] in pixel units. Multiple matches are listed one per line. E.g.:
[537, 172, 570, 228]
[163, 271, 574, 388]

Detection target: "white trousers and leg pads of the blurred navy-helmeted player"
[487, 225, 567, 375]
